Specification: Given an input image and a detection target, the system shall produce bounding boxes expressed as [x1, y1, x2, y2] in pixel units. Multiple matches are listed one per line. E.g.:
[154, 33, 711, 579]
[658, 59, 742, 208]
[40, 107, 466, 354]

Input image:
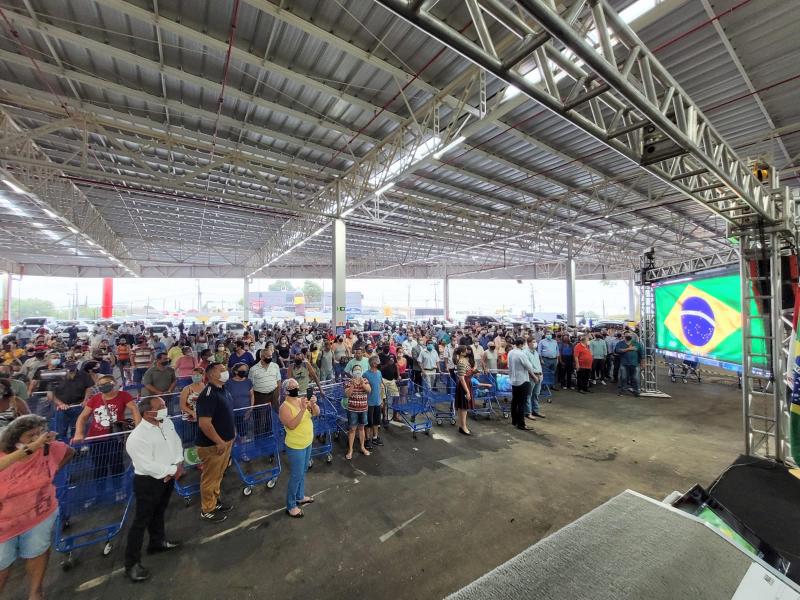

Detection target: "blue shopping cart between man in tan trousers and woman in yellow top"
[232, 404, 283, 496]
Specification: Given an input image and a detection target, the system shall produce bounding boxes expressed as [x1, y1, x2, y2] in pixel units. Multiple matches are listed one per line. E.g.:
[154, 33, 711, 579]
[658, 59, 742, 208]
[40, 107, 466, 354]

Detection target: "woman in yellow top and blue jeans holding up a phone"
[279, 379, 319, 519]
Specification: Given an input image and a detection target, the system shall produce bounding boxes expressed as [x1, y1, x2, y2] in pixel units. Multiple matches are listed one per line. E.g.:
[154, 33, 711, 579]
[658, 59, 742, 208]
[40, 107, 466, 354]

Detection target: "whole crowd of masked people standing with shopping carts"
[0, 321, 644, 597]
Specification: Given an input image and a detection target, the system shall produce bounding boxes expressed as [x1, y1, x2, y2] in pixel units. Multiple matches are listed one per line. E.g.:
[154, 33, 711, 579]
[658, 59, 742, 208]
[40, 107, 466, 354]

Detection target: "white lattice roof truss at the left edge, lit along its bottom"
[0, 109, 139, 275]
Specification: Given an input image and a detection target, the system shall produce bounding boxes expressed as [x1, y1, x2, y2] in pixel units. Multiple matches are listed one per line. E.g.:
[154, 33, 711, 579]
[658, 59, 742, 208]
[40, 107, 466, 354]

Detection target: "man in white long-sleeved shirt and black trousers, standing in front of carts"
[125, 396, 183, 582]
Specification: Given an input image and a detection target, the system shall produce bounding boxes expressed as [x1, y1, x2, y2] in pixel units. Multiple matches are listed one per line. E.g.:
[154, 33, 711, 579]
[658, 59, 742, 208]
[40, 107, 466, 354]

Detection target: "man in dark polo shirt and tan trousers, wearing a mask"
[195, 363, 236, 523]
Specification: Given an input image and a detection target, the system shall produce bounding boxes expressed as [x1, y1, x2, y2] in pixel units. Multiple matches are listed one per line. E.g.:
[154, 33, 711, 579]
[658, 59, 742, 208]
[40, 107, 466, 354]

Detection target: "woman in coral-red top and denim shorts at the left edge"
[0, 415, 75, 598]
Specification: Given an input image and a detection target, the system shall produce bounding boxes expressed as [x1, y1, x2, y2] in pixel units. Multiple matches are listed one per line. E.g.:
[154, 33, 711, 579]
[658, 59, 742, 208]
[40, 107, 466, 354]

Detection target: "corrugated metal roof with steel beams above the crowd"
[0, 0, 800, 278]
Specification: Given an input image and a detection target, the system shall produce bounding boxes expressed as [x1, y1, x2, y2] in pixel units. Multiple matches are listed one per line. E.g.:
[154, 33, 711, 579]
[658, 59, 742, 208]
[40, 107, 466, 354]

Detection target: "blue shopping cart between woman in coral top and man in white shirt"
[55, 431, 133, 571]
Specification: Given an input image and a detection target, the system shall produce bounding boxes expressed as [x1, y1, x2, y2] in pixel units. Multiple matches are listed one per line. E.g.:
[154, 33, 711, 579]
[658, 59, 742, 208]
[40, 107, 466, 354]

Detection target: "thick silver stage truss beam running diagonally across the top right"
[377, 0, 785, 230]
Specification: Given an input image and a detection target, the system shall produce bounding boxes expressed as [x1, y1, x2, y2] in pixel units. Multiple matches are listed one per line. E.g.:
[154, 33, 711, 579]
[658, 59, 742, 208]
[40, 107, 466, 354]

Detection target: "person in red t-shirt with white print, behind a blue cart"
[72, 375, 141, 479]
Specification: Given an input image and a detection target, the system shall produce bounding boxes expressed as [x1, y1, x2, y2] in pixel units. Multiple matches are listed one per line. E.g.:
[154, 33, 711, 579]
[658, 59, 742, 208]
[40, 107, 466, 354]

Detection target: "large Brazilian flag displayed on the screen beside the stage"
[655, 275, 764, 364]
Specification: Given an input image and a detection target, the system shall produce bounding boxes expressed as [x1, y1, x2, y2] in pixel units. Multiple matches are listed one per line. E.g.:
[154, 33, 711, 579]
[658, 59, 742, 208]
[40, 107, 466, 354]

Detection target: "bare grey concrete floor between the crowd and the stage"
[6, 372, 743, 600]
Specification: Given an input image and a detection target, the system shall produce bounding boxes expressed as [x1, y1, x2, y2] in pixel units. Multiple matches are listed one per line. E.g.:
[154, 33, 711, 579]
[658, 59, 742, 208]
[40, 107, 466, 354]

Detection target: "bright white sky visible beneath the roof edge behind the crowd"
[4, 276, 638, 314]
